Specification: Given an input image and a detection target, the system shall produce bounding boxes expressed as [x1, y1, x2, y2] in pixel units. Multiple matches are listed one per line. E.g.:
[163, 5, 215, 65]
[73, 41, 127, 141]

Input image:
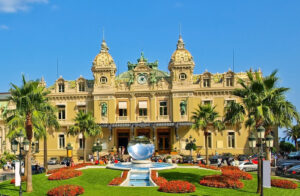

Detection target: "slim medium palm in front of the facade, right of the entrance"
[192, 104, 225, 164]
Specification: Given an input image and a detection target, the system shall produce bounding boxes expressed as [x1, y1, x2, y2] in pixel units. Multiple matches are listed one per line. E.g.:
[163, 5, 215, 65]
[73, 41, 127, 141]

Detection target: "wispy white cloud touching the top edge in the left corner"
[0, 0, 48, 13]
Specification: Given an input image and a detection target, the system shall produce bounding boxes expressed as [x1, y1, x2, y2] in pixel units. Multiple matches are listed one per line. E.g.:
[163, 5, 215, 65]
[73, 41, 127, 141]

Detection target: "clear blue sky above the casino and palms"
[0, 0, 300, 140]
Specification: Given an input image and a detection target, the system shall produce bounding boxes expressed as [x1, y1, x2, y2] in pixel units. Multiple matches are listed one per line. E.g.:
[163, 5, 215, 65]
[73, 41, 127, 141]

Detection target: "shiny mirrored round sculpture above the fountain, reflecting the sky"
[128, 136, 155, 160]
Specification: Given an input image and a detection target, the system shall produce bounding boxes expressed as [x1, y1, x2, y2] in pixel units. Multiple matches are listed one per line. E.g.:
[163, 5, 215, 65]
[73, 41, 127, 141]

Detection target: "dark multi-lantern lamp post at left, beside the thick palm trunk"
[11, 132, 29, 196]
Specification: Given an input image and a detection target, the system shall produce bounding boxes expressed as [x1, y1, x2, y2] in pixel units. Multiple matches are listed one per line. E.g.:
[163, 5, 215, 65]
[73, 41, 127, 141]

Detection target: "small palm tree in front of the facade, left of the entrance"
[68, 111, 102, 162]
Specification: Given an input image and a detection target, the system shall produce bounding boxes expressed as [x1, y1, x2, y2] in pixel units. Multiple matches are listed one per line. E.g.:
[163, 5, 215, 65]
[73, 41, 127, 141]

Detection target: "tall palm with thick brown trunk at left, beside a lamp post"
[10, 75, 49, 192]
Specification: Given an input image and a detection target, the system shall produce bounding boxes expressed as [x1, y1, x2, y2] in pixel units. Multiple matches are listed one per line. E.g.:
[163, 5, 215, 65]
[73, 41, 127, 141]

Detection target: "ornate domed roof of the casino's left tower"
[93, 40, 116, 68]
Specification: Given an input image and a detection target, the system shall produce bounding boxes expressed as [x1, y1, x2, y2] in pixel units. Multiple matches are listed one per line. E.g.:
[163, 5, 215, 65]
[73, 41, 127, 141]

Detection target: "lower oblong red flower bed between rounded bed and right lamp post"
[200, 175, 244, 189]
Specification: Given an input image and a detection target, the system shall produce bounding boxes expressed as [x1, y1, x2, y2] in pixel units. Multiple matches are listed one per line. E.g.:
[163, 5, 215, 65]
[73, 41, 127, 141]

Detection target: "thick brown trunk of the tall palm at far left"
[26, 113, 33, 193]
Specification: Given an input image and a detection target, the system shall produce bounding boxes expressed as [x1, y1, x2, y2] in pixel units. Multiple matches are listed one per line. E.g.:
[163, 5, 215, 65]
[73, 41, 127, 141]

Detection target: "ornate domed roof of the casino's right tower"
[169, 35, 195, 69]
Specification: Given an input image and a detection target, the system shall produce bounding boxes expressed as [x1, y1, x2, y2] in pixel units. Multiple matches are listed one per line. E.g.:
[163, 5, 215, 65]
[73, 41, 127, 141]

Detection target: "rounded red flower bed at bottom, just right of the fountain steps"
[158, 180, 196, 193]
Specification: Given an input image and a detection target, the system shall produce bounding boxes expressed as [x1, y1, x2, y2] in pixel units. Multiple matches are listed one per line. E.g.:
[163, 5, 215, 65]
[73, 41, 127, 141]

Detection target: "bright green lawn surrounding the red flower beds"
[0, 169, 300, 196]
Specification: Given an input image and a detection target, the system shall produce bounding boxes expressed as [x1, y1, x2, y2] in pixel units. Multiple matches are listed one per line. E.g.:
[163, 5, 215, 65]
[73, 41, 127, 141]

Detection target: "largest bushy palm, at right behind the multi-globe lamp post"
[225, 70, 298, 193]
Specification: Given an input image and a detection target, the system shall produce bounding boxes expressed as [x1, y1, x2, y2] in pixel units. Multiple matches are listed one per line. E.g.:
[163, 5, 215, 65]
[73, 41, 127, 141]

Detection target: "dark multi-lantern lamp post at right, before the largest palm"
[248, 126, 273, 196]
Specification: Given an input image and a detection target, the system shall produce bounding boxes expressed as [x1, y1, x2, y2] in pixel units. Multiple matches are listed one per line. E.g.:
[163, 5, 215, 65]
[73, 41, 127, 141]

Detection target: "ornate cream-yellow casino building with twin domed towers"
[0, 36, 278, 162]
